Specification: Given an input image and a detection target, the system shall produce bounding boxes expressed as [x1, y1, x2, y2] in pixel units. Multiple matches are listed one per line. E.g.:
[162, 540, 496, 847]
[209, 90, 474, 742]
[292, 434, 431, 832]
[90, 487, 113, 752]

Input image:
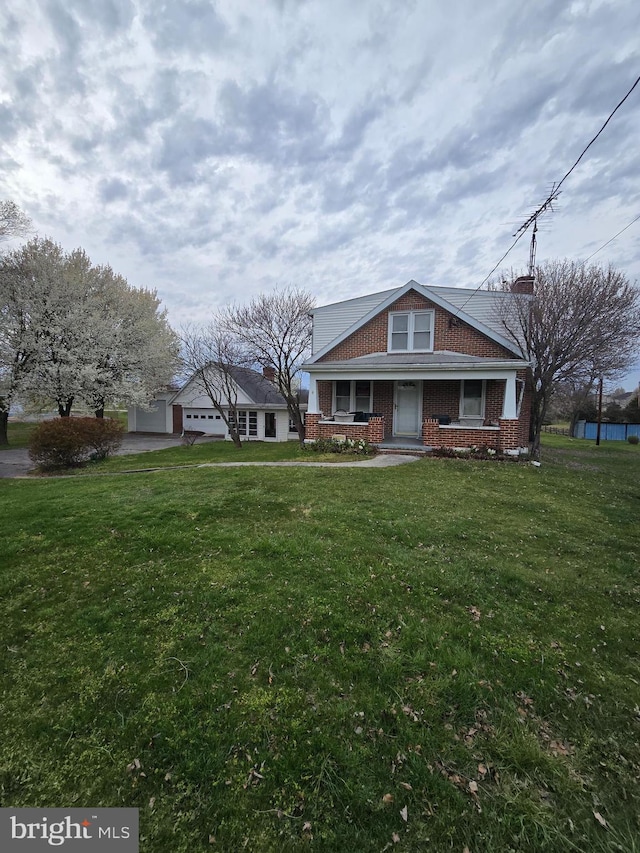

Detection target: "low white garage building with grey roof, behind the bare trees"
[129, 367, 298, 441]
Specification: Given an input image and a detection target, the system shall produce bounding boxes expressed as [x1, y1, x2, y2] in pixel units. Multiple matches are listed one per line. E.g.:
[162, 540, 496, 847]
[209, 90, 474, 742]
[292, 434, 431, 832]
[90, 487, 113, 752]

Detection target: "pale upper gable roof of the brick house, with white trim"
[307, 279, 522, 364]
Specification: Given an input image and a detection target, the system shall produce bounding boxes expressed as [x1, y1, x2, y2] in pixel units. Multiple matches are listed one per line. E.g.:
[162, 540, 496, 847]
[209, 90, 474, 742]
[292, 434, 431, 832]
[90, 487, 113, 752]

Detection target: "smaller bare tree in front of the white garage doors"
[180, 315, 250, 447]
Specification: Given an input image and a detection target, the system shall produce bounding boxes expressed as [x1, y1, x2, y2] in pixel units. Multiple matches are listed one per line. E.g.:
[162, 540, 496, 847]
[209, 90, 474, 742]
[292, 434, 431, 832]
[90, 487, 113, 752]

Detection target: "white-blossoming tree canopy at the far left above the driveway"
[0, 238, 179, 443]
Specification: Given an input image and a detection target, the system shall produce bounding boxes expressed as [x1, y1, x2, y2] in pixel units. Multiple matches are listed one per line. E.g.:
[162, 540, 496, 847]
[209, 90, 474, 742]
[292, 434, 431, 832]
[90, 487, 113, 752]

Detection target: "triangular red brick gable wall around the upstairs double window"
[320, 290, 515, 362]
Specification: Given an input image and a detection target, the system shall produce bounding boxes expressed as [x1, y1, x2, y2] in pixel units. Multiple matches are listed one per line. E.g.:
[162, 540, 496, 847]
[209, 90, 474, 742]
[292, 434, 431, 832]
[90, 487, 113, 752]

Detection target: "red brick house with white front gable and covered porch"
[303, 277, 533, 455]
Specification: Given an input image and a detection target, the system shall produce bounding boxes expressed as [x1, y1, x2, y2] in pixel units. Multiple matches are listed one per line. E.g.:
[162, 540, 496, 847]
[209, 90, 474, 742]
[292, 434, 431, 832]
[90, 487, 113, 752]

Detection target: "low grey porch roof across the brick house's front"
[303, 350, 529, 373]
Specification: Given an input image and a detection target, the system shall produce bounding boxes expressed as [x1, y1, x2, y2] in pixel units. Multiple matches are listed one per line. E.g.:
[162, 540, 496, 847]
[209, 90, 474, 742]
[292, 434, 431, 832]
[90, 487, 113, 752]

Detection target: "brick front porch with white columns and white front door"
[306, 359, 528, 453]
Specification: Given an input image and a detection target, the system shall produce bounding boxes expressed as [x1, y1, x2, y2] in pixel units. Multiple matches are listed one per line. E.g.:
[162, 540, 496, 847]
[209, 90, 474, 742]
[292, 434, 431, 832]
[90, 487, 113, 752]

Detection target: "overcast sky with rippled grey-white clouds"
[0, 0, 640, 382]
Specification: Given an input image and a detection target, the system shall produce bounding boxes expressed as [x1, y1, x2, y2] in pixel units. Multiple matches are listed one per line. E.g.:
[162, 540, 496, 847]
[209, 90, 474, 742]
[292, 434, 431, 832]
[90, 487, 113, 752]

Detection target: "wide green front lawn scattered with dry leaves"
[0, 436, 640, 853]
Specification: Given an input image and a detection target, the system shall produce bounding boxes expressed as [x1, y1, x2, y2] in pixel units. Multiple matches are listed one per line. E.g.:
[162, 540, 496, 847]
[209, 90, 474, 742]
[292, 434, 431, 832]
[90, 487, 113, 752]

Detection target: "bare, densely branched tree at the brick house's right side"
[499, 260, 640, 459]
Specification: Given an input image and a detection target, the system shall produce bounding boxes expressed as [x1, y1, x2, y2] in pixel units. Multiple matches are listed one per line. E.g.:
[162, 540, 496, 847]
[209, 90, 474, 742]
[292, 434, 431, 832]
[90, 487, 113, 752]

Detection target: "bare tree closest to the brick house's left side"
[223, 287, 314, 444]
